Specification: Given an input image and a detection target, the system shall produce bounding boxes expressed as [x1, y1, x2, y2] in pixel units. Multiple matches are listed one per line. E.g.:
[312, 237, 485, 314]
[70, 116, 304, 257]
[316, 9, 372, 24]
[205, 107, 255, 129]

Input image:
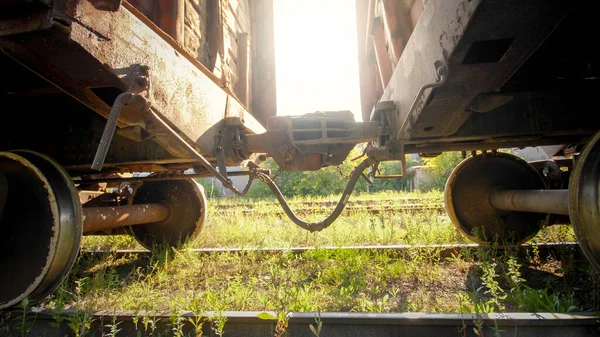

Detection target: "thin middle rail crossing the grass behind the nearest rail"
[81, 242, 581, 258]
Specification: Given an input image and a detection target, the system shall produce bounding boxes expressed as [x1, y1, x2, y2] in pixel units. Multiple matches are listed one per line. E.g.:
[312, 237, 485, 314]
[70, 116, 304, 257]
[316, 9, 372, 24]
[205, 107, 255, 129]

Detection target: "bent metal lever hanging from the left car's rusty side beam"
[92, 65, 150, 171]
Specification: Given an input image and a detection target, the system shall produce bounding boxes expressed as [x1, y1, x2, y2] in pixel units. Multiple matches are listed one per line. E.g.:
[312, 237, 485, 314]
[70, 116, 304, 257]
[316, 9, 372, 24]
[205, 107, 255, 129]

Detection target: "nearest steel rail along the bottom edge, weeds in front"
[0, 310, 600, 337]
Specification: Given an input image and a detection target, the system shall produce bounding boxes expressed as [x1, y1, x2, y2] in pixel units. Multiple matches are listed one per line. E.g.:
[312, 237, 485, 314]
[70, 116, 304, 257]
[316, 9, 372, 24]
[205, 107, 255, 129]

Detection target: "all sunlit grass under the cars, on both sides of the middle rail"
[57, 192, 600, 326]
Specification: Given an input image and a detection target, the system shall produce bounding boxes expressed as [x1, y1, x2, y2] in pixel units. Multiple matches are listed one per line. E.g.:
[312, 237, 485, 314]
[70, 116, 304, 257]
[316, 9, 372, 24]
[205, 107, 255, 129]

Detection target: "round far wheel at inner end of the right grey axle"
[444, 153, 546, 247]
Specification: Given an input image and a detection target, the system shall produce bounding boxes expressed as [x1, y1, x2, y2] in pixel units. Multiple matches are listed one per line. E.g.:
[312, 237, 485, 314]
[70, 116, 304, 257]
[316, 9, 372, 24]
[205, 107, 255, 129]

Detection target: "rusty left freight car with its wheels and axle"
[0, 0, 276, 308]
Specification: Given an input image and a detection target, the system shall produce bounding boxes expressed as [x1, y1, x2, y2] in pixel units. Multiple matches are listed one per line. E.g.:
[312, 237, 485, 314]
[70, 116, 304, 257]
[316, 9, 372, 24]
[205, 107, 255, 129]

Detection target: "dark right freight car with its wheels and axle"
[357, 0, 600, 270]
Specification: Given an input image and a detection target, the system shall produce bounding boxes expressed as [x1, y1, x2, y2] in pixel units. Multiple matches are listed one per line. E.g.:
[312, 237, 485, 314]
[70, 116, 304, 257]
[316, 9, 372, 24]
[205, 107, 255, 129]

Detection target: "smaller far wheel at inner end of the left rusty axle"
[129, 179, 207, 249]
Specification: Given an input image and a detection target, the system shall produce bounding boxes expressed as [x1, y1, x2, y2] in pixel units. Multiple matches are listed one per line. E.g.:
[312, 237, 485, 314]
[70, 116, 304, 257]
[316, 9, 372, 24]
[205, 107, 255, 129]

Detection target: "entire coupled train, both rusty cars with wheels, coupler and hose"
[0, 0, 600, 309]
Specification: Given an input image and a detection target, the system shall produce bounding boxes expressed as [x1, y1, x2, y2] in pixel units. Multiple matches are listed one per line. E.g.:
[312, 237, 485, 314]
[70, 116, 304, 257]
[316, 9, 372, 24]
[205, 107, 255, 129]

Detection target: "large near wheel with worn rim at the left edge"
[0, 151, 82, 309]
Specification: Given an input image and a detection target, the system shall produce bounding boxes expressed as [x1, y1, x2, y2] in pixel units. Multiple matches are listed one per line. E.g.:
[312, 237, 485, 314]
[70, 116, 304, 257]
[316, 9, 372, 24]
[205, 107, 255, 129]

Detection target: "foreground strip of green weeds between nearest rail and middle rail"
[43, 242, 600, 313]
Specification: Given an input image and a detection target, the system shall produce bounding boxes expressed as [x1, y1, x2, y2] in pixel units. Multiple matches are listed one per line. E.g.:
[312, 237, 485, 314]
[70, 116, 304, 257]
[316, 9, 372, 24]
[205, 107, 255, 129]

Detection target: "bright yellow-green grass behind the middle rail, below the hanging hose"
[82, 191, 576, 249]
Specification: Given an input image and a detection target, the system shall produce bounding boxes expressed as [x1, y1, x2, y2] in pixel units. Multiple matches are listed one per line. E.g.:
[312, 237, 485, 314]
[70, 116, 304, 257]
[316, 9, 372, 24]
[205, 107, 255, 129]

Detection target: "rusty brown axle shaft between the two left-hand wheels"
[83, 204, 169, 233]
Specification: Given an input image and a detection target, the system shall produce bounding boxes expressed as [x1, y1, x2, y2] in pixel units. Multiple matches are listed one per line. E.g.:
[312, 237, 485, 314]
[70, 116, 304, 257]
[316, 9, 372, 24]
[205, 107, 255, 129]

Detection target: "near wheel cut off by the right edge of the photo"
[569, 132, 600, 271]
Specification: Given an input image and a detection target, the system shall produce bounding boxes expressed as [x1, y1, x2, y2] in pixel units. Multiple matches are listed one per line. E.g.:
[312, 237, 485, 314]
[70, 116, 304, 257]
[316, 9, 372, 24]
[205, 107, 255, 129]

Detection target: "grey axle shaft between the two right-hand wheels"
[490, 190, 569, 215]
